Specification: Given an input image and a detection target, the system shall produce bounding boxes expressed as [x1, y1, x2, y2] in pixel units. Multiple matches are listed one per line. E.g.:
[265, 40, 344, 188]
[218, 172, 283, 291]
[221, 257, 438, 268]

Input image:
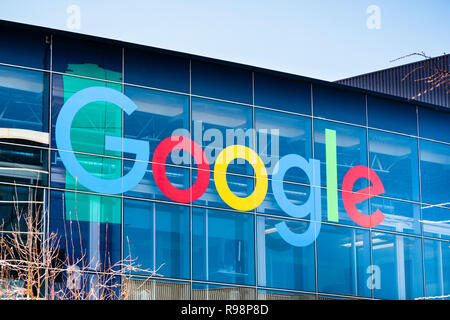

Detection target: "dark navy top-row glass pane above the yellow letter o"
[191, 60, 253, 104]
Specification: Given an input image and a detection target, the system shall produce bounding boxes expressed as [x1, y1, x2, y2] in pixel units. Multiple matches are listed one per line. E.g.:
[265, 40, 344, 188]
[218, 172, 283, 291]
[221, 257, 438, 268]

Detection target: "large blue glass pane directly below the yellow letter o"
[192, 208, 255, 285]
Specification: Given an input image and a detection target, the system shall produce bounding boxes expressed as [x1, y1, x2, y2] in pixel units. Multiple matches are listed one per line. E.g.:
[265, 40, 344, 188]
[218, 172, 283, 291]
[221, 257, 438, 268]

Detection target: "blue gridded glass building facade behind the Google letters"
[0, 23, 450, 299]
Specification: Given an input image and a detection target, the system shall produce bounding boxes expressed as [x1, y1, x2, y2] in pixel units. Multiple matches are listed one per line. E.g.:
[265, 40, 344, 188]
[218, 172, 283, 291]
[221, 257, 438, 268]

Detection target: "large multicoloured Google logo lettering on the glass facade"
[55, 87, 385, 247]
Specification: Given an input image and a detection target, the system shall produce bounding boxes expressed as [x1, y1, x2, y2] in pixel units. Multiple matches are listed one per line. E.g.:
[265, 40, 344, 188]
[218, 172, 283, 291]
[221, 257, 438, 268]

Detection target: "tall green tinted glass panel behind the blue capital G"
[63, 64, 122, 223]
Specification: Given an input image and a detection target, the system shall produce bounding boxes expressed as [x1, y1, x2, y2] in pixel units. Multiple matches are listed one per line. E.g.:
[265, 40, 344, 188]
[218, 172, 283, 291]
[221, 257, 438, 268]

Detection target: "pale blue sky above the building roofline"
[0, 0, 450, 81]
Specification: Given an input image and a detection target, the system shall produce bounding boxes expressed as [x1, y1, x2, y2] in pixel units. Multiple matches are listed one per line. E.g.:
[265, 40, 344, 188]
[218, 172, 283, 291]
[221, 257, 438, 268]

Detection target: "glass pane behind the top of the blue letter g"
[255, 109, 312, 184]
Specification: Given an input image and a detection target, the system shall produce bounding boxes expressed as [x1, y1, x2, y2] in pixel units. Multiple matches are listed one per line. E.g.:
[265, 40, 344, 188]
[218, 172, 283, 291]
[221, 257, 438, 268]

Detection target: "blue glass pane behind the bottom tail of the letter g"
[256, 216, 316, 291]
